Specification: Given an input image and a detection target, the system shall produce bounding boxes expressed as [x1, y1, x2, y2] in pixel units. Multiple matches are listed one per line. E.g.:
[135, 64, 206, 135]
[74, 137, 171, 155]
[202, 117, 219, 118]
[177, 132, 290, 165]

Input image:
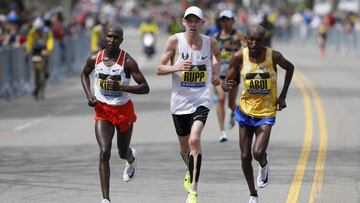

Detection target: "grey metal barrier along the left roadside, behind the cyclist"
[0, 32, 91, 99]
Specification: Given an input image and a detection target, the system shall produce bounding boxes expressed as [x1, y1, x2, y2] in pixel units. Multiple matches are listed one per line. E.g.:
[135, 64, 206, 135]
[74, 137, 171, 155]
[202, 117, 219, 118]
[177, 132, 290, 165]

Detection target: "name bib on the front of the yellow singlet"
[245, 72, 271, 95]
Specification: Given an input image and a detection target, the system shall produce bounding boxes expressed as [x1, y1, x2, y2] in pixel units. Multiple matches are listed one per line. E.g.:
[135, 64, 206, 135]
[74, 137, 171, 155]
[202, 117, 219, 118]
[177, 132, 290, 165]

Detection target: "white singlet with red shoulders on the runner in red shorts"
[94, 50, 130, 106]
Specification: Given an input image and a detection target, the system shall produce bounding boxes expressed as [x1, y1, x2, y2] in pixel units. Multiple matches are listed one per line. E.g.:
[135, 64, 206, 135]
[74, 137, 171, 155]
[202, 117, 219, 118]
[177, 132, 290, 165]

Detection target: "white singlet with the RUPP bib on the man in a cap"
[170, 33, 212, 115]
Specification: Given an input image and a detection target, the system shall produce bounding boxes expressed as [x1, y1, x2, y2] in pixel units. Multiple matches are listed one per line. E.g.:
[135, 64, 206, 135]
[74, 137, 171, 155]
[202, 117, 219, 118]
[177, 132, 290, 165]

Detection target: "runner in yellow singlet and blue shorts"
[222, 25, 294, 203]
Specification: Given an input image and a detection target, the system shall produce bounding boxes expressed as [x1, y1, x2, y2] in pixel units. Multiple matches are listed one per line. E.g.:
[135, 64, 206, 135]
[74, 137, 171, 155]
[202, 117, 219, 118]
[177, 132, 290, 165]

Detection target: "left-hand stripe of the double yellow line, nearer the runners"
[286, 71, 313, 203]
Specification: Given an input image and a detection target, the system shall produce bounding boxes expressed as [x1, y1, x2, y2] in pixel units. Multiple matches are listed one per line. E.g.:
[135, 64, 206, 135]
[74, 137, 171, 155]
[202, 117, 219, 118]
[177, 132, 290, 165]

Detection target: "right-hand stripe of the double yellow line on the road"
[301, 74, 328, 203]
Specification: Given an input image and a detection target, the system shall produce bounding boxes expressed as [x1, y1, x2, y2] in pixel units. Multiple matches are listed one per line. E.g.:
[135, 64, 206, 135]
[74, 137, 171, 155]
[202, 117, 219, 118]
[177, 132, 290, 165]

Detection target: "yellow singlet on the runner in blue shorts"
[240, 48, 277, 118]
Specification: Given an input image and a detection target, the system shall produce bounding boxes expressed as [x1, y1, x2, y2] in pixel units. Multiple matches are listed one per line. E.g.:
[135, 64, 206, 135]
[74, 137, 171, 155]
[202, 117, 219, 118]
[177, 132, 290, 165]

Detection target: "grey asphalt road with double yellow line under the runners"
[0, 29, 360, 203]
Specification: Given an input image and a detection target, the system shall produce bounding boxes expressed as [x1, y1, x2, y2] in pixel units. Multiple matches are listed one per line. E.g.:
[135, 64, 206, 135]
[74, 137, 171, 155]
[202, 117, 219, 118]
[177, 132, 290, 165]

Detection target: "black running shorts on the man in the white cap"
[172, 106, 210, 136]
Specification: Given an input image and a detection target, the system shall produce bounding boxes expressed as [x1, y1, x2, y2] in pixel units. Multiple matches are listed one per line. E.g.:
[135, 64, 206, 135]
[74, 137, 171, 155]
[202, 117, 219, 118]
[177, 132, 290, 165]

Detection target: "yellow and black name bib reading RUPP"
[181, 64, 206, 88]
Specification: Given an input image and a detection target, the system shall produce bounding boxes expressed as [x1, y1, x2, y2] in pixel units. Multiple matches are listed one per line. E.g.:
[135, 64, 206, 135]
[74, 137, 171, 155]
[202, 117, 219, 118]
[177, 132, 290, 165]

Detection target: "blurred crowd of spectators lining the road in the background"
[0, 0, 360, 47]
